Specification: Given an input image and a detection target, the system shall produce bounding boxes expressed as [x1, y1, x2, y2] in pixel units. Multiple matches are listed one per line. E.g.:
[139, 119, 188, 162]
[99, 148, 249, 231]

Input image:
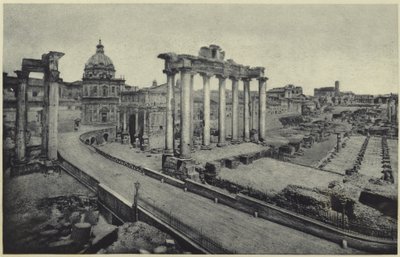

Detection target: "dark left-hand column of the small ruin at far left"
[15, 71, 29, 163]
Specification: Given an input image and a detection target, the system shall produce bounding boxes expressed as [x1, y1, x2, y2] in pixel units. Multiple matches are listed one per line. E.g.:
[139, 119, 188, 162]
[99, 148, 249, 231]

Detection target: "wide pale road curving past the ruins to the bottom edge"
[59, 132, 357, 254]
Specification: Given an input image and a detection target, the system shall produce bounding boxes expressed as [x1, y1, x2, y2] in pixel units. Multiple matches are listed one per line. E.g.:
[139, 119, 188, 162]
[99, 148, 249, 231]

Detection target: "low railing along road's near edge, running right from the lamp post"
[139, 198, 235, 254]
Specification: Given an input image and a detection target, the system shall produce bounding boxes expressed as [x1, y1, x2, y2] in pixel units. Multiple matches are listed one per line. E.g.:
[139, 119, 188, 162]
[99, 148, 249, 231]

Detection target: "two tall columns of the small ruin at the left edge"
[15, 67, 60, 160]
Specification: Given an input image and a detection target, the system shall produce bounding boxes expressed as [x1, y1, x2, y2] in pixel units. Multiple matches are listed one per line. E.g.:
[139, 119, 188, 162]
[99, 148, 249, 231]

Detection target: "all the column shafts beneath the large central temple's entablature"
[164, 68, 267, 159]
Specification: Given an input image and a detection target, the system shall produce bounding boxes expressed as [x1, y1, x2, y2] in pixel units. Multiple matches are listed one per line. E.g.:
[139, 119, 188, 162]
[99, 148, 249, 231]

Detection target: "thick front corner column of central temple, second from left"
[180, 68, 192, 159]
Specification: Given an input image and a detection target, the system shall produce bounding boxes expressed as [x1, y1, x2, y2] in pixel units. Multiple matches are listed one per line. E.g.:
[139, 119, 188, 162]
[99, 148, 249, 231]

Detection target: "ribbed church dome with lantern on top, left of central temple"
[84, 40, 115, 78]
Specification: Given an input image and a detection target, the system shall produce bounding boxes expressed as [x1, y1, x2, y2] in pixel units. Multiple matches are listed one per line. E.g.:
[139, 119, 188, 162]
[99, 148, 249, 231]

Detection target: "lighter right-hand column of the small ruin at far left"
[47, 70, 60, 160]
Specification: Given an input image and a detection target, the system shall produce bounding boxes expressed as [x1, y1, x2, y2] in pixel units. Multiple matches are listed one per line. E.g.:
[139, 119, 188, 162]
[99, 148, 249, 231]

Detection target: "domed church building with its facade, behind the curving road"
[82, 40, 125, 125]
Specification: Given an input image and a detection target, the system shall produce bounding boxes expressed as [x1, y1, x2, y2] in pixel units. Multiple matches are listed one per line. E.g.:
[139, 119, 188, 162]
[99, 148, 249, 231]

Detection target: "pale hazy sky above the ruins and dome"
[3, 4, 399, 94]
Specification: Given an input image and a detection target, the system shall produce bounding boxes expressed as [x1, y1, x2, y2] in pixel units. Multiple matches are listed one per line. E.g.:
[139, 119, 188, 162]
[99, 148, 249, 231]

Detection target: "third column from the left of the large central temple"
[201, 73, 211, 148]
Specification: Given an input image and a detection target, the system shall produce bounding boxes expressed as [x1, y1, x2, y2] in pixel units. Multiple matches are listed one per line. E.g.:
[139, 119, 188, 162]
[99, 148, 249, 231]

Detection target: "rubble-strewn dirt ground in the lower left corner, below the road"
[3, 167, 183, 254]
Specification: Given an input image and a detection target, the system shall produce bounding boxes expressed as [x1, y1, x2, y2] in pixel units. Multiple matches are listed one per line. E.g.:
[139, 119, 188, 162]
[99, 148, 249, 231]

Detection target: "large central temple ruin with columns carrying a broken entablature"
[158, 45, 268, 177]
